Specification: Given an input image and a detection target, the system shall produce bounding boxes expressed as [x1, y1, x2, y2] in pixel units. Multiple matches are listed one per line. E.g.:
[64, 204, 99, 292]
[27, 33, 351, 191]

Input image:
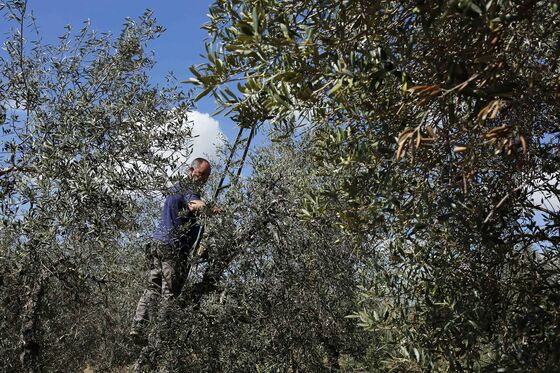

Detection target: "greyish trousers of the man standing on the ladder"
[133, 243, 190, 328]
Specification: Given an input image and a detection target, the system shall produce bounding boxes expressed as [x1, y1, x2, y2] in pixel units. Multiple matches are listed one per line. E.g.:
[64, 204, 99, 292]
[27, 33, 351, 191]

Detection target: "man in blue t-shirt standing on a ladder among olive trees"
[130, 158, 211, 342]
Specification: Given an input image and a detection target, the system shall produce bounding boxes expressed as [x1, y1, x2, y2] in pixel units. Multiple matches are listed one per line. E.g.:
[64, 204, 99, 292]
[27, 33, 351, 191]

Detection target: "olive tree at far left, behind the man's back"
[0, 1, 194, 372]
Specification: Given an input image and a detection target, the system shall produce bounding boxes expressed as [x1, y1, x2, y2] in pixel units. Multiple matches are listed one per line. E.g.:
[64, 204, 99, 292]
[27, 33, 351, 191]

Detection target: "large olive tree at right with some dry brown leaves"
[191, 0, 560, 371]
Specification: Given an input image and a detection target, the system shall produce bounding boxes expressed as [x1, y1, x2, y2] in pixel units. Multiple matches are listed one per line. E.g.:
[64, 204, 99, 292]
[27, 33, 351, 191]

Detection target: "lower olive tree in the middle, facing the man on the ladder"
[135, 141, 369, 372]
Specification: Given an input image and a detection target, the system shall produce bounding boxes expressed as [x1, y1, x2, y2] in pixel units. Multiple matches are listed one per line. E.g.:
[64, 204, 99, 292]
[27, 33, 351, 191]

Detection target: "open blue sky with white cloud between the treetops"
[0, 0, 245, 160]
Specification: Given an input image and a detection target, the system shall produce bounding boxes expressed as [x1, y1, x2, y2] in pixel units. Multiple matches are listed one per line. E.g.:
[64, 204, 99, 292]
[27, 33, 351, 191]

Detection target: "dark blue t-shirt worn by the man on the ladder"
[152, 183, 200, 248]
